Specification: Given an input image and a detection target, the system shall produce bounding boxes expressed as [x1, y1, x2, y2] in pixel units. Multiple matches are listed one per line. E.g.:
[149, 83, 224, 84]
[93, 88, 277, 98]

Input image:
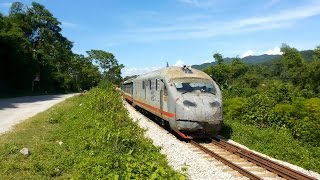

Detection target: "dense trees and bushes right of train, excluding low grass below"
[205, 44, 320, 147]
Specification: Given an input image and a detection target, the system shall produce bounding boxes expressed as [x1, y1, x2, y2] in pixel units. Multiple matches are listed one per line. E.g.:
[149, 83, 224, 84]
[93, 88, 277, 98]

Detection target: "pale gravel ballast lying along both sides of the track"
[125, 103, 320, 180]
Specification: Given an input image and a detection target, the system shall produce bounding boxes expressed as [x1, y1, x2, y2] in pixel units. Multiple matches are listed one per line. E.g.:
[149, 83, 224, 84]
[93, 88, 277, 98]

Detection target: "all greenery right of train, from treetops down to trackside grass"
[205, 44, 320, 172]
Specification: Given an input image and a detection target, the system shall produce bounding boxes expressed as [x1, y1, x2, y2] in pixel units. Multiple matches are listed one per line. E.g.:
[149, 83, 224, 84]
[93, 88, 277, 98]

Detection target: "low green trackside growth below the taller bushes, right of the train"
[221, 119, 320, 173]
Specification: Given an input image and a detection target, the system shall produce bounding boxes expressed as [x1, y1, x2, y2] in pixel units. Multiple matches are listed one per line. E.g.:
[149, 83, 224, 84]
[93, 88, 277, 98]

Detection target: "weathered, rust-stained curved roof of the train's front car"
[136, 66, 213, 81]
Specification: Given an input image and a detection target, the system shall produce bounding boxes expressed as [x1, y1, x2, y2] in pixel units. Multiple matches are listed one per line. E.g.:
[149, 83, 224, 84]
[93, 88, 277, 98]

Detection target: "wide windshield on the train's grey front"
[174, 81, 217, 94]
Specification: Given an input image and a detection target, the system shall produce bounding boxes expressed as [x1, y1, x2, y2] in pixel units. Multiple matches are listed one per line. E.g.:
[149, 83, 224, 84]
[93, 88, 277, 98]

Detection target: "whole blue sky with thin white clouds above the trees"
[0, 0, 320, 76]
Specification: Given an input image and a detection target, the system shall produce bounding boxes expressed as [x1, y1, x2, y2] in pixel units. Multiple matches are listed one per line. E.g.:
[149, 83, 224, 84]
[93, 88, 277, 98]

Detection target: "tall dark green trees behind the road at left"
[0, 2, 123, 96]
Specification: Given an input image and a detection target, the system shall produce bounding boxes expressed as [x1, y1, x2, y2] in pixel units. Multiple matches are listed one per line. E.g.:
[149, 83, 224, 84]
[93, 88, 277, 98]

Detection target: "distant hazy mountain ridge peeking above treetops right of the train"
[191, 50, 313, 70]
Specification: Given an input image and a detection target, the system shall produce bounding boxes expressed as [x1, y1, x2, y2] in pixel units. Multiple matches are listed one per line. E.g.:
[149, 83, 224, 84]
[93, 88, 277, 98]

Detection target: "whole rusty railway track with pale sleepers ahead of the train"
[190, 139, 315, 180]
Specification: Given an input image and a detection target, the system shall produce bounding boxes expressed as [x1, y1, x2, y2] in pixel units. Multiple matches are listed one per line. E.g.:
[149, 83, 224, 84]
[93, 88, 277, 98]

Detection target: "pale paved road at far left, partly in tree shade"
[0, 94, 76, 134]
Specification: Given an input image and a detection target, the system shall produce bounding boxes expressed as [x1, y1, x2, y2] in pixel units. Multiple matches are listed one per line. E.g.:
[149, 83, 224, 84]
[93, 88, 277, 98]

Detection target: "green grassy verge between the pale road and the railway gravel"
[0, 86, 185, 179]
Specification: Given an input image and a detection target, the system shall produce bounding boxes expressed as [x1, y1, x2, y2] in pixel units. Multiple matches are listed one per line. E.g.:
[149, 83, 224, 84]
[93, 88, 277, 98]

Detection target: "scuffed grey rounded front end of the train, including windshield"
[173, 78, 223, 138]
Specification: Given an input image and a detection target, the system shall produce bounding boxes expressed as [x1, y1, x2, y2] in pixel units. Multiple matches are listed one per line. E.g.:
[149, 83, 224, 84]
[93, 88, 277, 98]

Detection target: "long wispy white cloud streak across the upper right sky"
[121, 0, 320, 42]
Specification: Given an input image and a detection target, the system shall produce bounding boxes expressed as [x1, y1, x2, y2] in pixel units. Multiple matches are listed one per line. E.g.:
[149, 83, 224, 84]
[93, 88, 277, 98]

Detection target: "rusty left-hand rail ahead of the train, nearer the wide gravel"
[190, 140, 261, 180]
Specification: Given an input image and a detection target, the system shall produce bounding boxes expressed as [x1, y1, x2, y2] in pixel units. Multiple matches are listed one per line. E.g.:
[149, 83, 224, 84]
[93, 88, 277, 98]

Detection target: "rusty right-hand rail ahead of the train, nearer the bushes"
[212, 138, 316, 180]
